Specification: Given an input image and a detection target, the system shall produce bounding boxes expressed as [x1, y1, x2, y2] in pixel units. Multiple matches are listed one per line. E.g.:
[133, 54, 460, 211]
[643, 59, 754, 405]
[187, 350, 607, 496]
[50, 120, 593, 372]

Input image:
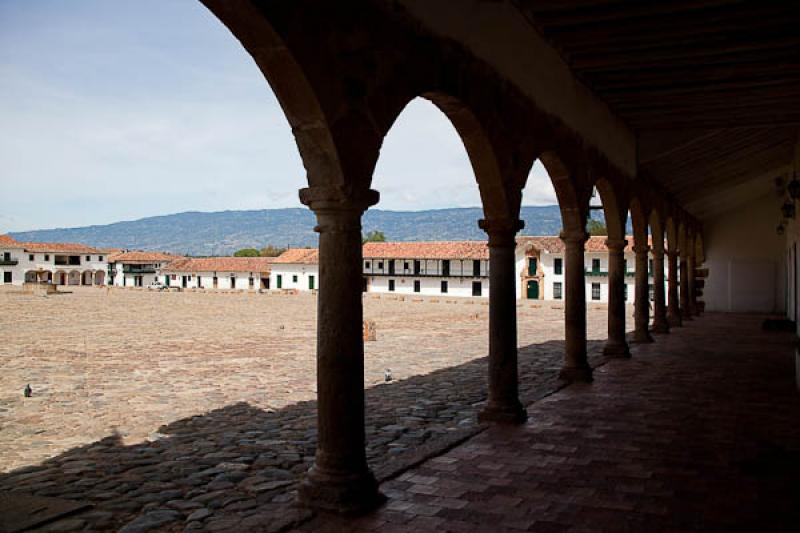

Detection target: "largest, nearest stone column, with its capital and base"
[298, 187, 381, 513]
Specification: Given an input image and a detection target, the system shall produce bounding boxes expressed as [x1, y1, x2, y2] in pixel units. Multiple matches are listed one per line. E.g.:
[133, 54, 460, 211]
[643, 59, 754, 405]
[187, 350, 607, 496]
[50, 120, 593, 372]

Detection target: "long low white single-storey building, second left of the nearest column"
[159, 257, 275, 290]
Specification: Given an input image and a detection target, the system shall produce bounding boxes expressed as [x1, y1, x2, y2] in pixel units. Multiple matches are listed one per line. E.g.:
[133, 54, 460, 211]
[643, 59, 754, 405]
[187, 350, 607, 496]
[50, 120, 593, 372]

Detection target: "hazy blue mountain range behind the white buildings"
[11, 205, 608, 255]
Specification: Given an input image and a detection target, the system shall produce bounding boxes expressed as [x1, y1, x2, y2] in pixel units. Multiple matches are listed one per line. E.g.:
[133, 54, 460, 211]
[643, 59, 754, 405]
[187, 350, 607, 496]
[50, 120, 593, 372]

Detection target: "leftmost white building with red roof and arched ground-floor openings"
[0, 235, 108, 285]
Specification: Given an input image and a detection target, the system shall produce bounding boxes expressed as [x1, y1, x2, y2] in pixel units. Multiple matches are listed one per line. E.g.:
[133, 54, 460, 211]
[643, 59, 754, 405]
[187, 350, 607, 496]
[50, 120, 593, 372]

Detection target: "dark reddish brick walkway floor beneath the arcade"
[301, 313, 800, 532]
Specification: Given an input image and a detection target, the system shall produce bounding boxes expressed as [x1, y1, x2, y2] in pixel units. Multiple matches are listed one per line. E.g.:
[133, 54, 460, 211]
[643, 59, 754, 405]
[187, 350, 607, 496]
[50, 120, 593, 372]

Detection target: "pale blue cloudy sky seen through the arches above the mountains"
[0, 0, 555, 233]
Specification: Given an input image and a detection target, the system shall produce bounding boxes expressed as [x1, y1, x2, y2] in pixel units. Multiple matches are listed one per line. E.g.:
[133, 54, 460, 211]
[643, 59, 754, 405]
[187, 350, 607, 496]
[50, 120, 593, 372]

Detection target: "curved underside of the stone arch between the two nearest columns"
[378, 91, 515, 219]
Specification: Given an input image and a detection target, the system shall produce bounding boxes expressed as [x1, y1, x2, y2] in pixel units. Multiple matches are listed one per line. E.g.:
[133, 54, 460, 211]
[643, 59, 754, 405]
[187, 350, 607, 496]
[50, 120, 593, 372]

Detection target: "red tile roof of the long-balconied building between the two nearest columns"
[363, 241, 489, 259]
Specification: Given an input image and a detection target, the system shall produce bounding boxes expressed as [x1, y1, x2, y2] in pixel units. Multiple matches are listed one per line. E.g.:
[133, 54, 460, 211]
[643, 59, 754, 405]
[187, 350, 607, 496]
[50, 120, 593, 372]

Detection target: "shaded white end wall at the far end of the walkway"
[702, 194, 786, 313]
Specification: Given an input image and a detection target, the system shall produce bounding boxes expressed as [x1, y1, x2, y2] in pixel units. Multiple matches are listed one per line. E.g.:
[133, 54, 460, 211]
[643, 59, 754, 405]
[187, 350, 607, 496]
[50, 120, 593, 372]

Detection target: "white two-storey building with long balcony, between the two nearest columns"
[363, 241, 489, 296]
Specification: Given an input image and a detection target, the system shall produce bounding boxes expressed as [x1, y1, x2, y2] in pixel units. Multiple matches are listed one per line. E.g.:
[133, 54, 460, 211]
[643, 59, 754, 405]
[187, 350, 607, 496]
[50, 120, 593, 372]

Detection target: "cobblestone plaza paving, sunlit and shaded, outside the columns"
[0, 287, 630, 531]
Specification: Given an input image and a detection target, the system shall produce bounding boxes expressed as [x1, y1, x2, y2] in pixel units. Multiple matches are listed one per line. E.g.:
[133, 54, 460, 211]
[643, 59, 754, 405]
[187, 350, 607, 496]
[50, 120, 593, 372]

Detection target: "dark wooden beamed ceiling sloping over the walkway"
[515, 0, 800, 217]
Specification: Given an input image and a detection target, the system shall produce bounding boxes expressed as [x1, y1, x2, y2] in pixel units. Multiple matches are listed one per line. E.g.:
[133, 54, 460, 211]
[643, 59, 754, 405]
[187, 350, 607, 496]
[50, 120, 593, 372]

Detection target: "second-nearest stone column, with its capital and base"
[478, 220, 528, 424]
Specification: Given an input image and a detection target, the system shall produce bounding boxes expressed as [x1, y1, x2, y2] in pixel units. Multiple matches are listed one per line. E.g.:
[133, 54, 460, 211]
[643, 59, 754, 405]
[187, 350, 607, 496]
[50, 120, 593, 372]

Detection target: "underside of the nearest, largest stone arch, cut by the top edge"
[200, 0, 352, 193]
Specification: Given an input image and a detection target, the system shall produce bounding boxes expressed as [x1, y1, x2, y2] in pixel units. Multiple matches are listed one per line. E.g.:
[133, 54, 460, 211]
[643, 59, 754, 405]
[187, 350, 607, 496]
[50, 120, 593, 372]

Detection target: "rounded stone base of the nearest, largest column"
[297, 465, 386, 515]
